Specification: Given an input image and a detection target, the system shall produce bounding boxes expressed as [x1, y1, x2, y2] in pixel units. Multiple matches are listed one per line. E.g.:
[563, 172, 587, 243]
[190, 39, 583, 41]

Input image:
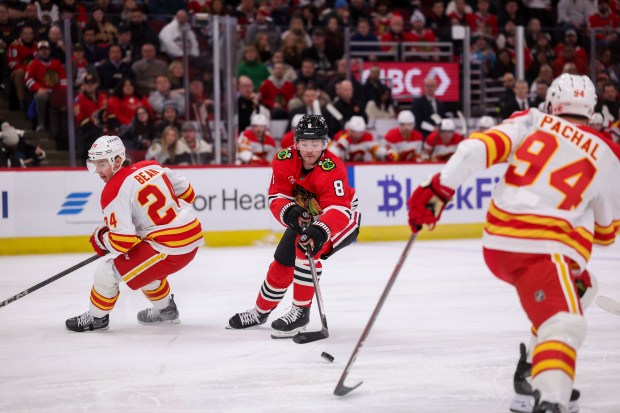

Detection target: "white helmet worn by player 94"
[545, 73, 597, 118]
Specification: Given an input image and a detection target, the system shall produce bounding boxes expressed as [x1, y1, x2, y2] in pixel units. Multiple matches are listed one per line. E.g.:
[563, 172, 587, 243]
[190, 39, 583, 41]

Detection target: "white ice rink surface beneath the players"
[0, 240, 620, 413]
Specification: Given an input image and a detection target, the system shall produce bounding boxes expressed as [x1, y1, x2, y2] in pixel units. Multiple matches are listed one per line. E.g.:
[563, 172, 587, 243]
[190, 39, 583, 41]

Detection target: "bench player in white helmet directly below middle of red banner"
[384, 110, 424, 162]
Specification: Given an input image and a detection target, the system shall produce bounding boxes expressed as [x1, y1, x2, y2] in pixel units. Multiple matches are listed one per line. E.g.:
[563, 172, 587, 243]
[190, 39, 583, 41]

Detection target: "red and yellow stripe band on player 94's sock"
[532, 341, 577, 380]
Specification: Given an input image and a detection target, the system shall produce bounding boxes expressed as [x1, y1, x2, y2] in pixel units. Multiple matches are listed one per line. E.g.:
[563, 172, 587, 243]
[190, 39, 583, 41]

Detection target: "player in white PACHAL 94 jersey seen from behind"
[408, 74, 620, 413]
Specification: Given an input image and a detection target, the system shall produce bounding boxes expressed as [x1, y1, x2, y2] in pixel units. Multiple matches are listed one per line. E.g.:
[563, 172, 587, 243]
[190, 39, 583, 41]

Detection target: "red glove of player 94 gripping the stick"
[407, 174, 454, 233]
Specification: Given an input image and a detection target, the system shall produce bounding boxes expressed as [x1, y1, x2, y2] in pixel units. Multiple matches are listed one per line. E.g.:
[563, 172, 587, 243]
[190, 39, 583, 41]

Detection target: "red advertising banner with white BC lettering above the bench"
[360, 62, 461, 102]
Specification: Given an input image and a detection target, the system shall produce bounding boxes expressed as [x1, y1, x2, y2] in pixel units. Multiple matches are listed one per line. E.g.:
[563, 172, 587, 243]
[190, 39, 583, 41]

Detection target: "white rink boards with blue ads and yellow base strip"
[0, 164, 505, 255]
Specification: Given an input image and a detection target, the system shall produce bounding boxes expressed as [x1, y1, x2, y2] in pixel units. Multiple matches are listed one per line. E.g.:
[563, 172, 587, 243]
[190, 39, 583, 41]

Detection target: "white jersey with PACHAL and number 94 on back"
[440, 109, 620, 269]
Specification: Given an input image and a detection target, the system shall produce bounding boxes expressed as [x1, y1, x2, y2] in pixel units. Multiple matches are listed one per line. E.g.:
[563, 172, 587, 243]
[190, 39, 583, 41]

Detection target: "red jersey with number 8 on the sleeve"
[269, 148, 360, 244]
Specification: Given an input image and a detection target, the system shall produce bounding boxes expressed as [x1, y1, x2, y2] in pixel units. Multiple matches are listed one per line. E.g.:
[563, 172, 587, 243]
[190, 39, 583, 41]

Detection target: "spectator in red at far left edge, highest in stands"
[7, 26, 36, 111]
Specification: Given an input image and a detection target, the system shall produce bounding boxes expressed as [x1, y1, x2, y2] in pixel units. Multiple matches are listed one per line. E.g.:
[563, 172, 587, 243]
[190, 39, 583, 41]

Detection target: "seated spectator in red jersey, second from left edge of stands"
[25, 40, 67, 141]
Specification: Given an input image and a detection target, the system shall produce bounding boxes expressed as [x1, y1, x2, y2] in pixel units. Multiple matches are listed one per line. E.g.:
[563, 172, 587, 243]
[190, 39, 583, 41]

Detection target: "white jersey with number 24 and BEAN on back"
[101, 161, 204, 255]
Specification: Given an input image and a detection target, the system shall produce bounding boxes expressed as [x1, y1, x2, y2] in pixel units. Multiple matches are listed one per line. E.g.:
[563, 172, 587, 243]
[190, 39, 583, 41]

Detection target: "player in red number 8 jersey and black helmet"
[228, 115, 360, 338]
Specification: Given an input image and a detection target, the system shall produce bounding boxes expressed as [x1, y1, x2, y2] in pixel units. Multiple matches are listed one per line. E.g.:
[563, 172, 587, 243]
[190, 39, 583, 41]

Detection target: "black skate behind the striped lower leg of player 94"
[510, 343, 580, 413]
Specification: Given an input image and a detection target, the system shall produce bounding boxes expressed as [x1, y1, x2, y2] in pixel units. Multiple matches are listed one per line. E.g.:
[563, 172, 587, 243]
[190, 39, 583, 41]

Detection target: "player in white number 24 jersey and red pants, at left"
[66, 136, 204, 332]
